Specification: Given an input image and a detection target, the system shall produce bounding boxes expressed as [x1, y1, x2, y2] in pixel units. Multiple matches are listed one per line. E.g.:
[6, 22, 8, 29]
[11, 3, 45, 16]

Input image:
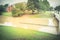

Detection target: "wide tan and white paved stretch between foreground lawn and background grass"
[0, 15, 57, 34]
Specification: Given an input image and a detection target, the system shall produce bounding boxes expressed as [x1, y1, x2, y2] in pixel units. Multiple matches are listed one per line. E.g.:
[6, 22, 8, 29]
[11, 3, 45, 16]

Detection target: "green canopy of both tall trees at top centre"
[27, 0, 50, 10]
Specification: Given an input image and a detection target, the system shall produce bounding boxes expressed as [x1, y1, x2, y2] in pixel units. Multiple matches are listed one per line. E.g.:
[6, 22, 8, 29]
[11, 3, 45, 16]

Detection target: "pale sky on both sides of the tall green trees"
[0, 0, 60, 7]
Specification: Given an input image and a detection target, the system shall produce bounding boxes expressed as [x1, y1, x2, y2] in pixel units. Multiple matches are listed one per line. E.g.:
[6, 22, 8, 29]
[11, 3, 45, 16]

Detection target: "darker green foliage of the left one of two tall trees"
[27, 0, 40, 10]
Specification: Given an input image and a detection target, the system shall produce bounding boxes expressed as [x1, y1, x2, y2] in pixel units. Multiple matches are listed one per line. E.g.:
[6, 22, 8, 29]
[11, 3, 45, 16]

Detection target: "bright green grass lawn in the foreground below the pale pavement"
[0, 25, 57, 40]
